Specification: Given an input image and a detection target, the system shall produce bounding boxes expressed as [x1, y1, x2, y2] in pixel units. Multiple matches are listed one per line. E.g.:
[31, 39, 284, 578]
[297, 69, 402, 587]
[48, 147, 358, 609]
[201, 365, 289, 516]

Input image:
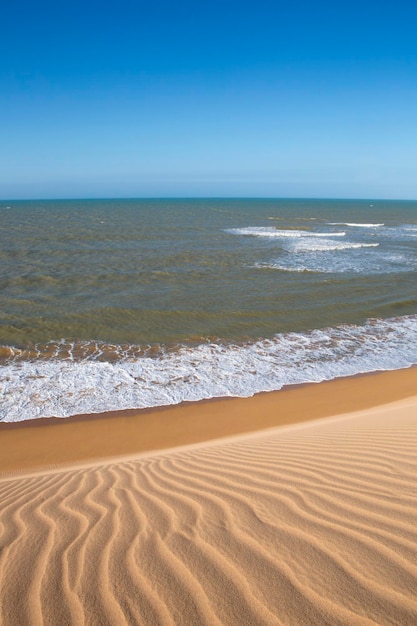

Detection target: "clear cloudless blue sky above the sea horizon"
[0, 0, 417, 199]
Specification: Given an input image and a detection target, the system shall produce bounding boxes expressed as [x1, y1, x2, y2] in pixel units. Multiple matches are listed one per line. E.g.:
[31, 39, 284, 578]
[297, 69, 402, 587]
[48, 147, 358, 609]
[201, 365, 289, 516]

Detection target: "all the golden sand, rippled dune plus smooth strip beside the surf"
[0, 369, 417, 626]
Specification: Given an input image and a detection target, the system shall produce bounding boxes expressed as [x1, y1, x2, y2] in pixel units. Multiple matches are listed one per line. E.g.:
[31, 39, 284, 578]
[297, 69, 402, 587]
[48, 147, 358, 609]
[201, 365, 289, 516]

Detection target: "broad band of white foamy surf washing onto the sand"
[0, 315, 417, 422]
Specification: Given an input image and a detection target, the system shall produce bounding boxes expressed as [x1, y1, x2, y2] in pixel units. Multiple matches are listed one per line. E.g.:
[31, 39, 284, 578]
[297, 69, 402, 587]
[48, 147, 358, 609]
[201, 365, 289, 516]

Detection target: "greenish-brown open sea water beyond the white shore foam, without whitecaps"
[0, 199, 417, 346]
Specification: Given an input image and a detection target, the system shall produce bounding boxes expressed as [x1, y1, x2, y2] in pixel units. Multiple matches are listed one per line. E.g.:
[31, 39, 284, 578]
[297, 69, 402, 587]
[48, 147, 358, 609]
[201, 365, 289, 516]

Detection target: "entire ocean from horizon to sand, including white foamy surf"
[0, 199, 417, 422]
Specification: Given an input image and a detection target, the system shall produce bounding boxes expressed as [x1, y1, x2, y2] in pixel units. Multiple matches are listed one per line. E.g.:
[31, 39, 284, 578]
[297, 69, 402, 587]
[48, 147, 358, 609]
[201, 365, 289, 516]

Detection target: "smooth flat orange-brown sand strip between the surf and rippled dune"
[0, 366, 417, 475]
